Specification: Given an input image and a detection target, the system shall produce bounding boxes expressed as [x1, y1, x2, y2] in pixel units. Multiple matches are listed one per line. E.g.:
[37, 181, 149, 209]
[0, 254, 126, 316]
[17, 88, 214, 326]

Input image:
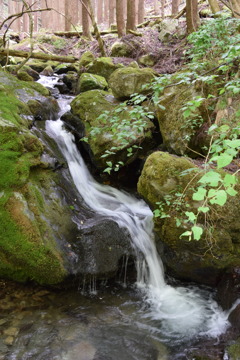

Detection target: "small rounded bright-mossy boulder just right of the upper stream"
[77, 73, 108, 94]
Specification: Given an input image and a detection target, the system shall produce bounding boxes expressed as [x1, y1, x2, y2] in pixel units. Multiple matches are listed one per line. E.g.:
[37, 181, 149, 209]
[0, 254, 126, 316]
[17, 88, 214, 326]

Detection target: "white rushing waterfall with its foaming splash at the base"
[41, 76, 231, 337]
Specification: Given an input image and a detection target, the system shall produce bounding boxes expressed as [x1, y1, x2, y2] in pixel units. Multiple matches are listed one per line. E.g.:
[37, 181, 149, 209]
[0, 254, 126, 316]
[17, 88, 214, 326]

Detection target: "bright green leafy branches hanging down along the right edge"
[153, 19, 240, 240]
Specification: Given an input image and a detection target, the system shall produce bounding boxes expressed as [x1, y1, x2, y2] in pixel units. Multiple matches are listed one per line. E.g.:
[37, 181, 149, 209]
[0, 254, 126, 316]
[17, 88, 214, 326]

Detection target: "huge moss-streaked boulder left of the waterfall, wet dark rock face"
[0, 72, 132, 285]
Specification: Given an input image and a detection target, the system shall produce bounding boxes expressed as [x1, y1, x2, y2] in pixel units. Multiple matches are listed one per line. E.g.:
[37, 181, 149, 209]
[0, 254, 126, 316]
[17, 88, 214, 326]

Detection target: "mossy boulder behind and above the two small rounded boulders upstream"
[87, 57, 123, 80]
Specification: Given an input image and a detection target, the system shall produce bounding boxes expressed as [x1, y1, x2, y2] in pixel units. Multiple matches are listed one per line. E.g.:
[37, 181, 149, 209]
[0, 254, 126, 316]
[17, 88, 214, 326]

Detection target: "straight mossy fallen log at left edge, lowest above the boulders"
[0, 49, 78, 63]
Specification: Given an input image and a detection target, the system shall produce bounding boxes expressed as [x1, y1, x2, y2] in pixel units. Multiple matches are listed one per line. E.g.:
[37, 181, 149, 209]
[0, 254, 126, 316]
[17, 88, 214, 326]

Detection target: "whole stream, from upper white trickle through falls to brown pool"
[0, 77, 233, 360]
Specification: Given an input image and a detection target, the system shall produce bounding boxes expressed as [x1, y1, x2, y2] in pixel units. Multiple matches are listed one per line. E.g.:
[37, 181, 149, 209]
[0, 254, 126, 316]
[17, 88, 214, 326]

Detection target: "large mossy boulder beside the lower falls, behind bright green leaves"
[138, 152, 240, 285]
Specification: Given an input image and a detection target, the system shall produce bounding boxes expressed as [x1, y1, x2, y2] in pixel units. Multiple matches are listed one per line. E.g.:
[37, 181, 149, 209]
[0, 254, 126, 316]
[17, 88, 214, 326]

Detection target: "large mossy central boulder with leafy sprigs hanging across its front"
[71, 90, 155, 169]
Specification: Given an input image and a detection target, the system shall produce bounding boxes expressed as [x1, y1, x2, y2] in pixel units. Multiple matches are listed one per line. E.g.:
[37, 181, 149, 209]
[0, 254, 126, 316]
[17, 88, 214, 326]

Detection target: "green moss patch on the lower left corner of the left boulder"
[0, 200, 65, 284]
